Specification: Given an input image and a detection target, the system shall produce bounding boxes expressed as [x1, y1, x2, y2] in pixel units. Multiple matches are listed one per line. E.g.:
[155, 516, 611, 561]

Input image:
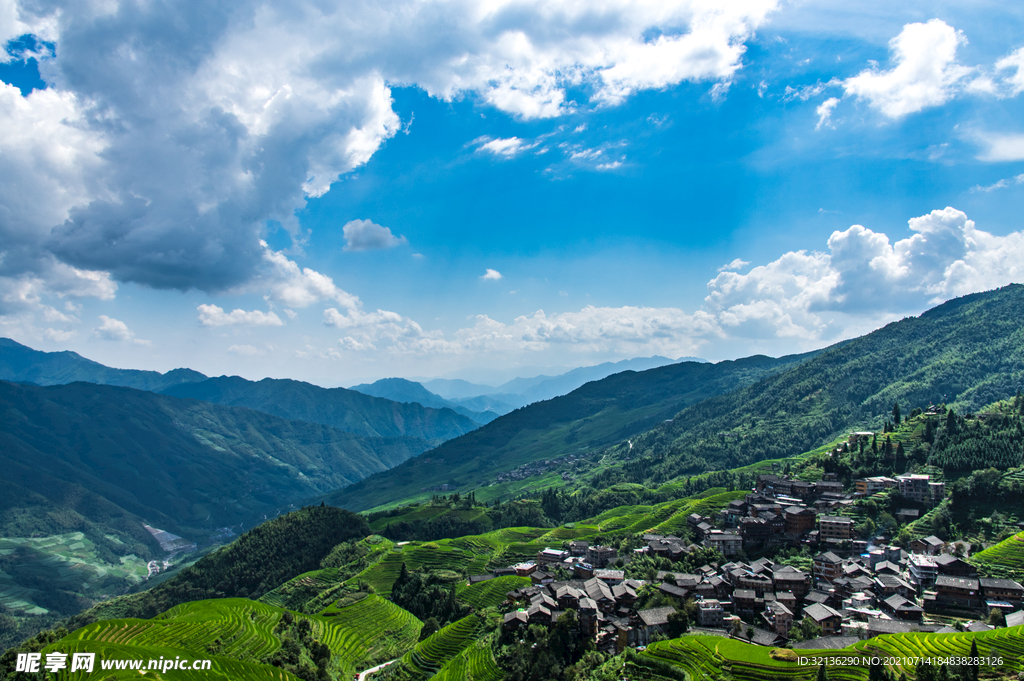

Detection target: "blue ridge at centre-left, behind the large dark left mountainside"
[162, 376, 479, 443]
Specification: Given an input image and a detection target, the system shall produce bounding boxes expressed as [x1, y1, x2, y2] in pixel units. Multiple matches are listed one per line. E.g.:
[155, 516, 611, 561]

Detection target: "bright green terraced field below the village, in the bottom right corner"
[642, 627, 1024, 681]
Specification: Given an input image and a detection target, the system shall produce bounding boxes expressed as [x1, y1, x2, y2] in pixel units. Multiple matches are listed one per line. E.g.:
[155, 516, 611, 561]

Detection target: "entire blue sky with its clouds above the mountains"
[0, 0, 1024, 385]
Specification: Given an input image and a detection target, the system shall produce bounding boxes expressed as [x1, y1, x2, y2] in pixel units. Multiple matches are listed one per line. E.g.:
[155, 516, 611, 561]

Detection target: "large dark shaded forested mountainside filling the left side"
[0, 382, 426, 544]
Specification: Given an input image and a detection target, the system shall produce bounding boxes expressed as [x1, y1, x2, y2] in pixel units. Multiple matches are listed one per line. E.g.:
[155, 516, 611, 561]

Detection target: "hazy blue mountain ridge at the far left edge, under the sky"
[0, 338, 207, 391]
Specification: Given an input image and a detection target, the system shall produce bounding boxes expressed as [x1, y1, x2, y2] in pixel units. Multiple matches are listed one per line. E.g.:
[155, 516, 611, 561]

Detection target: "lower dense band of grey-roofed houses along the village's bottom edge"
[493, 535, 1024, 651]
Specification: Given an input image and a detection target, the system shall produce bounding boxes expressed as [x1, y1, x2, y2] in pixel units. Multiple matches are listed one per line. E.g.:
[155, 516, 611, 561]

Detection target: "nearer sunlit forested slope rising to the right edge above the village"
[594, 285, 1024, 485]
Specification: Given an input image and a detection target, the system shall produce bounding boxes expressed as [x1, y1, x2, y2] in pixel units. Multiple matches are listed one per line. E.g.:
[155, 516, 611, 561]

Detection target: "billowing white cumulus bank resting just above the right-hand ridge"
[706, 208, 1024, 340]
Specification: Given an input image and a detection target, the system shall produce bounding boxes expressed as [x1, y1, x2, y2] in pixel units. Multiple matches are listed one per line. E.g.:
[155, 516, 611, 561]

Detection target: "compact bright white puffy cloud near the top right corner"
[843, 18, 975, 119]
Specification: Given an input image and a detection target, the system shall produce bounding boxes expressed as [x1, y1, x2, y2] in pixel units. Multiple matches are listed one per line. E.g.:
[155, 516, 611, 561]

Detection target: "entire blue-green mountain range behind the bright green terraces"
[0, 285, 1024, 659]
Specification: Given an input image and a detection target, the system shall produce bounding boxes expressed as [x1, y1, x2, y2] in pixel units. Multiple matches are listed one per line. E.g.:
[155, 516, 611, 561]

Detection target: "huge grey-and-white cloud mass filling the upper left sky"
[0, 0, 778, 303]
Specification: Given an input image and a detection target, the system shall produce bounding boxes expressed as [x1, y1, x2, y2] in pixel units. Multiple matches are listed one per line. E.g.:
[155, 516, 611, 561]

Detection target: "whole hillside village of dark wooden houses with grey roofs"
[481, 433, 1024, 652]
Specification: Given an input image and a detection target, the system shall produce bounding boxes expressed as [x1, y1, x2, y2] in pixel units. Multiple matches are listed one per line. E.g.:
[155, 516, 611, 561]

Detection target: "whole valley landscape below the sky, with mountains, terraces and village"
[0, 286, 1024, 681]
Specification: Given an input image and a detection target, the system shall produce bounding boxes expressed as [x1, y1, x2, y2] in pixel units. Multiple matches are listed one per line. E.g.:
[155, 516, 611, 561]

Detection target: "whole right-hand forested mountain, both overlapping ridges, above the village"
[326, 285, 1024, 510]
